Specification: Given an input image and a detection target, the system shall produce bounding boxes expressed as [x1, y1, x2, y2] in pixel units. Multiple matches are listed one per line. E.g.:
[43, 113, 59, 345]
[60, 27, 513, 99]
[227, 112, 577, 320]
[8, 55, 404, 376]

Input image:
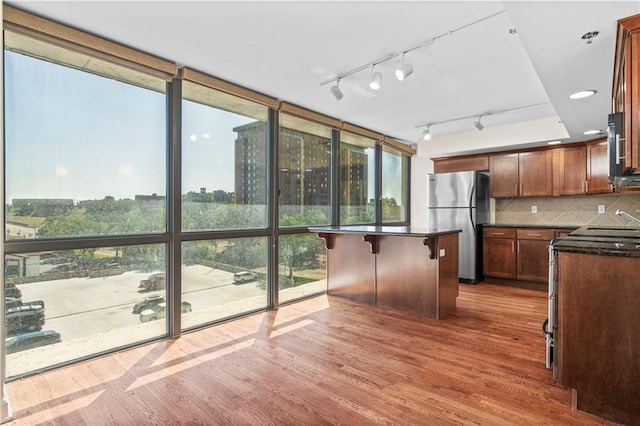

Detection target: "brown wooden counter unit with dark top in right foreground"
[549, 226, 640, 424]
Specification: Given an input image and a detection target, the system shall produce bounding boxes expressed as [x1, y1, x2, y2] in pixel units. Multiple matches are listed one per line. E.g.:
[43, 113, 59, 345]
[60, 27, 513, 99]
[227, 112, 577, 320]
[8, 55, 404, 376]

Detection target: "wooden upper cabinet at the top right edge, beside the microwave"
[611, 15, 640, 169]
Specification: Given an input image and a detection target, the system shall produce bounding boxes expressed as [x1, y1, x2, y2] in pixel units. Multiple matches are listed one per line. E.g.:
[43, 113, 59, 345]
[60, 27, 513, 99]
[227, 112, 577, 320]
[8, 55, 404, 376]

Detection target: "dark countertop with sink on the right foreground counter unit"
[552, 226, 640, 257]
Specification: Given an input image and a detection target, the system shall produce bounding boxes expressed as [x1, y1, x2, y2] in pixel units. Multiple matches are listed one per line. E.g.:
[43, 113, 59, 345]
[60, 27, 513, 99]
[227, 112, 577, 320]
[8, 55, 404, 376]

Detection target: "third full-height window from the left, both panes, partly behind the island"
[278, 114, 332, 303]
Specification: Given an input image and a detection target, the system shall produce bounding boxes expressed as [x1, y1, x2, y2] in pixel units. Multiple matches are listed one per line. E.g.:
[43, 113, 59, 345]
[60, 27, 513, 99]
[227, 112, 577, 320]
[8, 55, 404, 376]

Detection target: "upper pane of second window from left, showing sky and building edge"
[182, 82, 267, 231]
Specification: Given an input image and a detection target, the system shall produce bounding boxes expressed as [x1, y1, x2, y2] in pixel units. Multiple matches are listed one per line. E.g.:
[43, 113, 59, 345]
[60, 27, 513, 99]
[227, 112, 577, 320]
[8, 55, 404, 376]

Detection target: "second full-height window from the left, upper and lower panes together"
[181, 81, 268, 328]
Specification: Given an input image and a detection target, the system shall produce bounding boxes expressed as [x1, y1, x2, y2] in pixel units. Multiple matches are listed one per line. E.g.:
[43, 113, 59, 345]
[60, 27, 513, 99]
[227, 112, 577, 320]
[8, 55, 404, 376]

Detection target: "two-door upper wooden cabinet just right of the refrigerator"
[489, 150, 553, 198]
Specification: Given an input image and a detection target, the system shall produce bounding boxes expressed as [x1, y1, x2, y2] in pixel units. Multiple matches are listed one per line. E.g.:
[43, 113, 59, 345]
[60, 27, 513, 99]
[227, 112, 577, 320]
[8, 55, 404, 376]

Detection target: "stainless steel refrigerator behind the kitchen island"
[427, 172, 490, 284]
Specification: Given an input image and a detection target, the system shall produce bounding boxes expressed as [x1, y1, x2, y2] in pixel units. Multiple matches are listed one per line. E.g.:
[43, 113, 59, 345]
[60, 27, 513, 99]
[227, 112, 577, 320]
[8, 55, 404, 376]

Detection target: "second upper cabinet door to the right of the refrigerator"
[519, 150, 553, 197]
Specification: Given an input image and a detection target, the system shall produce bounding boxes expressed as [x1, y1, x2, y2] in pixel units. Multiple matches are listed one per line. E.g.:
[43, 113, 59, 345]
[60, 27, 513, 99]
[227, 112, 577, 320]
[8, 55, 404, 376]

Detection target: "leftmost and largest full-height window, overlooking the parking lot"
[4, 33, 167, 376]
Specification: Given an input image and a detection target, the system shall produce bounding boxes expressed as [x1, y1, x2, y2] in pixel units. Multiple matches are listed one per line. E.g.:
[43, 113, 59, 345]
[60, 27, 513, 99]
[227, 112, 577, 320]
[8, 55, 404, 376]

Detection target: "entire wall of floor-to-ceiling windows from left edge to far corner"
[3, 7, 408, 378]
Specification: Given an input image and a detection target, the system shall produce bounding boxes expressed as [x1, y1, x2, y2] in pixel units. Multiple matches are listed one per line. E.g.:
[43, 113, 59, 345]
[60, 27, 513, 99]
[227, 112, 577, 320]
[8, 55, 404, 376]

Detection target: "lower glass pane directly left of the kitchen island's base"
[278, 234, 327, 303]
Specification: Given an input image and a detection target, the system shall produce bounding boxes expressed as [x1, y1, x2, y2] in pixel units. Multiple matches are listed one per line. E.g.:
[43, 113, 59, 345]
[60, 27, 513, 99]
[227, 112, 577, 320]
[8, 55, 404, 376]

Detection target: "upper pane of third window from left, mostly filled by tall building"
[279, 114, 331, 227]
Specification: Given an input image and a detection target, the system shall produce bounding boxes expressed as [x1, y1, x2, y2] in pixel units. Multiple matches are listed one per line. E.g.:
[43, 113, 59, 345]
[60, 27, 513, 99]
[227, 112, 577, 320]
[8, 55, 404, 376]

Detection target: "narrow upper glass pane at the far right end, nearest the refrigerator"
[382, 150, 407, 222]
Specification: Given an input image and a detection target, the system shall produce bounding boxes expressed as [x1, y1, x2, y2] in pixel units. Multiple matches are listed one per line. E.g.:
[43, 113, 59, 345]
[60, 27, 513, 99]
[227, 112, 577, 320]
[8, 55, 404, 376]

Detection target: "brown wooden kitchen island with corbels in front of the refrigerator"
[309, 226, 460, 318]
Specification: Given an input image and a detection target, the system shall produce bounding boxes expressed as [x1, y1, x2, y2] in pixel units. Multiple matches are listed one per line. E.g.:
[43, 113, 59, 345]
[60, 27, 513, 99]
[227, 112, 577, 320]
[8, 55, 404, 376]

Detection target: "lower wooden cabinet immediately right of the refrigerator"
[482, 227, 516, 279]
